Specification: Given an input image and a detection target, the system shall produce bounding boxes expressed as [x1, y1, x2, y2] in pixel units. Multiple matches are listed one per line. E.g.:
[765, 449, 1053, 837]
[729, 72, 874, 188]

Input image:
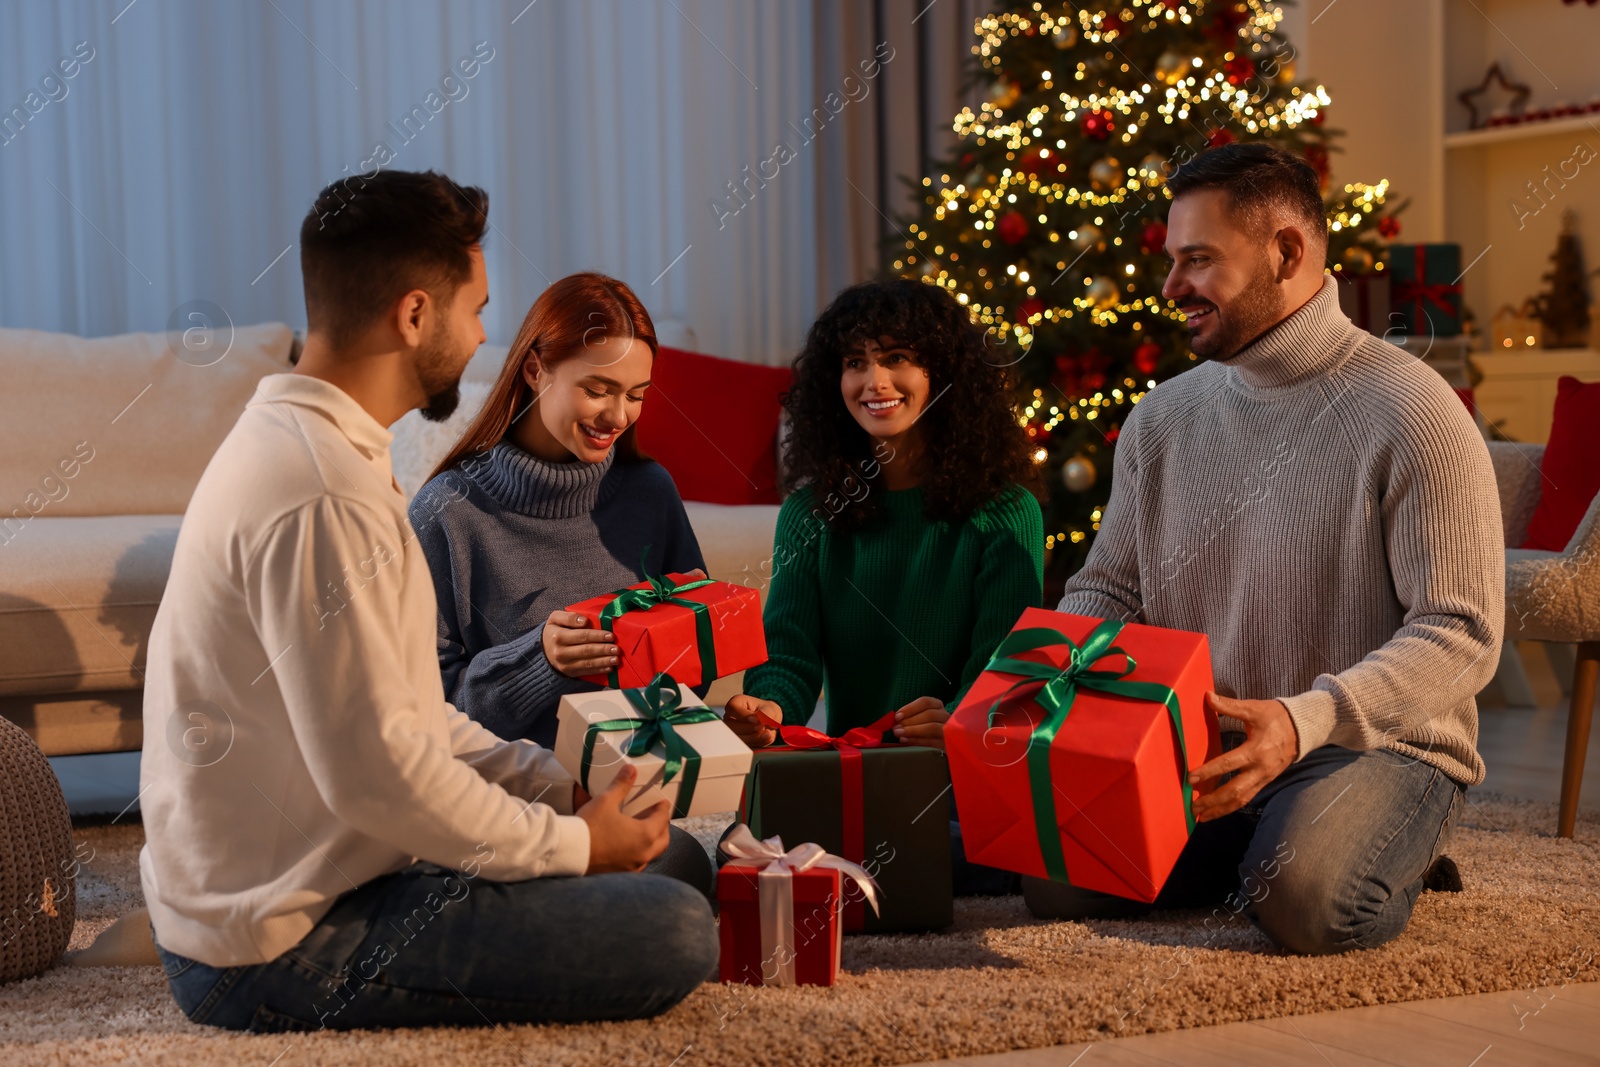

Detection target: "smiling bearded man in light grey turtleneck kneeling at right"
[1027, 144, 1504, 953]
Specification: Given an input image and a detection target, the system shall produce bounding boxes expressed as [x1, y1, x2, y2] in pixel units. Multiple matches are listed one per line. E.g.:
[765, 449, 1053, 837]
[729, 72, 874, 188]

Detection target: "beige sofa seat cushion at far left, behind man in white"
[0, 515, 181, 694]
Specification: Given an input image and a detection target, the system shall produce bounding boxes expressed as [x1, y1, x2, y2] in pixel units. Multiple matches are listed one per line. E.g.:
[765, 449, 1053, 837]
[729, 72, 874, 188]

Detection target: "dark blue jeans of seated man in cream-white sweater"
[157, 845, 717, 1032]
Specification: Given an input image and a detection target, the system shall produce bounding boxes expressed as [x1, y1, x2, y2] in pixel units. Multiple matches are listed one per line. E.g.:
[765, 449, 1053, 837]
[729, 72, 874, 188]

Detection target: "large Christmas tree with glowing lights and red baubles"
[893, 0, 1398, 574]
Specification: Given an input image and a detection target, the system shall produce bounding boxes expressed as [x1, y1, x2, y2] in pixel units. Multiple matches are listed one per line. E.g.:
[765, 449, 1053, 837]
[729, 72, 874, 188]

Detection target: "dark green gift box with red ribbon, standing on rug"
[739, 713, 955, 934]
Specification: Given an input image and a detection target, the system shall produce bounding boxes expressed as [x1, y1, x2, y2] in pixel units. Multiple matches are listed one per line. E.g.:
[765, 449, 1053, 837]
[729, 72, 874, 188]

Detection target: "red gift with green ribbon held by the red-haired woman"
[566, 574, 766, 689]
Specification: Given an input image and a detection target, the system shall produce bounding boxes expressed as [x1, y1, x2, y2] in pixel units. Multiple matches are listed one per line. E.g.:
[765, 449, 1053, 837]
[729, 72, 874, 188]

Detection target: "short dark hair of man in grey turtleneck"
[1166, 141, 1328, 243]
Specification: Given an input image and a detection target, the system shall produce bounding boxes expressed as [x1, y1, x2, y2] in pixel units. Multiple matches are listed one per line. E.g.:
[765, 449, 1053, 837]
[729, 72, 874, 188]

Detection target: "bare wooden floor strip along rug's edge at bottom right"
[938, 984, 1600, 1067]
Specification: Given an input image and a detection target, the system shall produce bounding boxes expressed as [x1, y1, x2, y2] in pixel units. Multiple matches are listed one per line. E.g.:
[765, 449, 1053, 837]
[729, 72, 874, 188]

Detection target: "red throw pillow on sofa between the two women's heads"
[638, 347, 794, 504]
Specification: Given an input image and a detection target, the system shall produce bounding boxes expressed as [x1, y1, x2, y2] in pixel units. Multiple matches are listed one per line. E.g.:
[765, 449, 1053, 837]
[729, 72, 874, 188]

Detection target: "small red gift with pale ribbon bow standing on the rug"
[717, 825, 878, 985]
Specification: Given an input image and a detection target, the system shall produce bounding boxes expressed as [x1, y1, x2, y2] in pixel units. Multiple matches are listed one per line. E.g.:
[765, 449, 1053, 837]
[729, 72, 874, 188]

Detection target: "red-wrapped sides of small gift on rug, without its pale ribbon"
[717, 864, 845, 985]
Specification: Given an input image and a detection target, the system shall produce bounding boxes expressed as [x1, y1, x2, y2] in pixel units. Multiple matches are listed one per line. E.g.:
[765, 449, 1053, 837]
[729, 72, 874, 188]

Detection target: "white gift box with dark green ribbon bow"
[555, 673, 750, 819]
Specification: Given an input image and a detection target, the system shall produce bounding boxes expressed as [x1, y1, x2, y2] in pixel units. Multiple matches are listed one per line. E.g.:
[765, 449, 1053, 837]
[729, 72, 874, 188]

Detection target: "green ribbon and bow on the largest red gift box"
[984, 619, 1195, 881]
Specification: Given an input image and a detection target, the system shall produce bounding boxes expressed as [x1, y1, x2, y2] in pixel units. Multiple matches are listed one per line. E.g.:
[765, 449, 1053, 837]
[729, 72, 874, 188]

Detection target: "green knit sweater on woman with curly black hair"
[744, 485, 1045, 736]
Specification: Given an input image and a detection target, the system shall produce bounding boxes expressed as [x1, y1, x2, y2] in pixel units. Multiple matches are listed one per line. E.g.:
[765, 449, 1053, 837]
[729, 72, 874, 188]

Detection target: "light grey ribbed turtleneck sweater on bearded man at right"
[1061, 277, 1506, 785]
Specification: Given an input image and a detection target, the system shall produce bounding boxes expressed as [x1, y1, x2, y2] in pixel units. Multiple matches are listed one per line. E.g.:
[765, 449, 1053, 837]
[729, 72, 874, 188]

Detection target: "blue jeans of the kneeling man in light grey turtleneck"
[1022, 745, 1466, 955]
